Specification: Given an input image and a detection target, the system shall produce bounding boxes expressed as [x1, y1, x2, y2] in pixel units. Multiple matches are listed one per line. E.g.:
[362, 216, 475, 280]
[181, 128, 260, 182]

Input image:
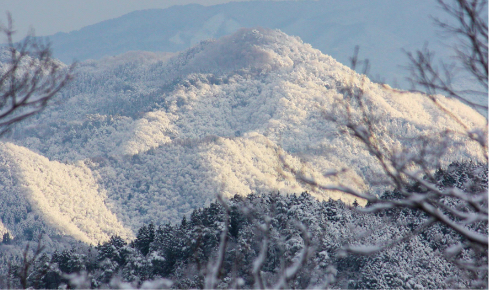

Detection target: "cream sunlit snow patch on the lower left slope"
[0, 143, 132, 245]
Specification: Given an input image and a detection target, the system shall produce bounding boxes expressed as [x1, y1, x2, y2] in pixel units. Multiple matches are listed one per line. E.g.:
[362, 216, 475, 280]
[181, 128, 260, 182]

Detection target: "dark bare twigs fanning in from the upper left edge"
[0, 13, 75, 136]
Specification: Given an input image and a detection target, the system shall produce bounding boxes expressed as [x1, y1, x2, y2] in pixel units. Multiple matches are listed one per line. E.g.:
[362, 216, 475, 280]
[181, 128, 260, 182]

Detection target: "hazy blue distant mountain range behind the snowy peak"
[43, 0, 451, 87]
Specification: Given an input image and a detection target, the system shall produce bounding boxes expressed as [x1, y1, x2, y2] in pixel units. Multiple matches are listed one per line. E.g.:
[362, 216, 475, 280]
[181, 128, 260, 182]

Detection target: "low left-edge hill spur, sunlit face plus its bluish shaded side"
[0, 143, 132, 244]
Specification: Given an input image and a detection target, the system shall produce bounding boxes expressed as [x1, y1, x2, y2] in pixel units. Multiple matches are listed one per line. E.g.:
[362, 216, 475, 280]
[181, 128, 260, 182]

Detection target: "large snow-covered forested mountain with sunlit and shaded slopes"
[0, 28, 485, 243]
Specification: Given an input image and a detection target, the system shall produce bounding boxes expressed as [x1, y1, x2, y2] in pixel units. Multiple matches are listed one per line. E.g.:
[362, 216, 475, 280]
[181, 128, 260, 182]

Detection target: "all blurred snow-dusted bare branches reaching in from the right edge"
[282, 11, 488, 285]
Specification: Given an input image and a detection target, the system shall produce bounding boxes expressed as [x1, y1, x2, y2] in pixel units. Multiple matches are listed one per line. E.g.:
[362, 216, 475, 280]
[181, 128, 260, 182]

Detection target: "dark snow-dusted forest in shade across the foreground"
[0, 162, 488, 289]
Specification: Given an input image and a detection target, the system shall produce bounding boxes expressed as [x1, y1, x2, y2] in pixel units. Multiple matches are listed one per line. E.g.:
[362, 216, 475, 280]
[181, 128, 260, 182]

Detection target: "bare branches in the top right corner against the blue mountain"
[406, 0, 488, 111]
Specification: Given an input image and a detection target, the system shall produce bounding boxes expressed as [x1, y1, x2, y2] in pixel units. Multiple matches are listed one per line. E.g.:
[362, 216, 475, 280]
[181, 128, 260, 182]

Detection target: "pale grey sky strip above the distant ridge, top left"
[0, 0, 252, 43]
